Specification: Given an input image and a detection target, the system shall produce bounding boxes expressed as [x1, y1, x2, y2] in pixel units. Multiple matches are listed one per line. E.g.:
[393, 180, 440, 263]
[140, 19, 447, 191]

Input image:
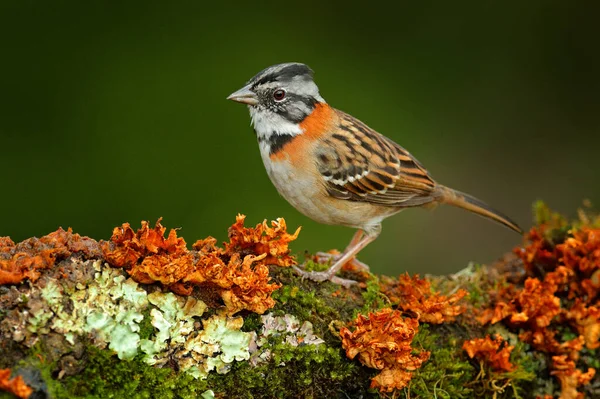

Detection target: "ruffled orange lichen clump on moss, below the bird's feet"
[340, 308, 429, 392]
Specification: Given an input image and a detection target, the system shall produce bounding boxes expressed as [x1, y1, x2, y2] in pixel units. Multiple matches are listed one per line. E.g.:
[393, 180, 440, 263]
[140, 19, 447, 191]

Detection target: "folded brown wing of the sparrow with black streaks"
[317, 111, 435, 207]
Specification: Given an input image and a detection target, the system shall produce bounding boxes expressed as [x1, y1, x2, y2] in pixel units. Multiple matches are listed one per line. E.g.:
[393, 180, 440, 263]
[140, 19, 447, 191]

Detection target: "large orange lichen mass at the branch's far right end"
[478, 212, 600, 399]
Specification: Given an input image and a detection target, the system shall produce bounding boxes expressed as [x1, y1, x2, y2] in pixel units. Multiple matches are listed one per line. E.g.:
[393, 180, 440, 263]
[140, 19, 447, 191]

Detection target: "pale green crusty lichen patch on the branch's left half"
[19, 261, 332, 386]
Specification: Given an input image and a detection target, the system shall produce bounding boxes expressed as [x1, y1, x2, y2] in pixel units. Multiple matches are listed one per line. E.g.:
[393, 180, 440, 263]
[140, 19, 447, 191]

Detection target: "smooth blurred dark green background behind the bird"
[0, 0, 600, 274]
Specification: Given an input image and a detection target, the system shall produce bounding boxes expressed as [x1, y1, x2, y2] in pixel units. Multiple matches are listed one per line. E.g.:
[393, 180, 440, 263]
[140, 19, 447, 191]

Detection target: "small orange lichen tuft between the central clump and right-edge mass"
[463, 335, 515, 372]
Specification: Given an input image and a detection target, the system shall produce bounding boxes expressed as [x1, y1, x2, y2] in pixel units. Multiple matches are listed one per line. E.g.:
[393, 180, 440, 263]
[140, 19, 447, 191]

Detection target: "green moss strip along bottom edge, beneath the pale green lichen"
[20, 328, 364, 399]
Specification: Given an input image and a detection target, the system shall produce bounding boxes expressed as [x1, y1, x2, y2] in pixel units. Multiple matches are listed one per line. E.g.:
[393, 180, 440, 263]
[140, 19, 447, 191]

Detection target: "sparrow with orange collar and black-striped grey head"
[227, 62, 522, 285]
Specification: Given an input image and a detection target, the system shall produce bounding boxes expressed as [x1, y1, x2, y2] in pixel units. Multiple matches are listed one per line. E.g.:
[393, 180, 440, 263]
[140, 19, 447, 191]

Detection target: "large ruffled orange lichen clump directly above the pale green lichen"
[102, 215, 298, 314]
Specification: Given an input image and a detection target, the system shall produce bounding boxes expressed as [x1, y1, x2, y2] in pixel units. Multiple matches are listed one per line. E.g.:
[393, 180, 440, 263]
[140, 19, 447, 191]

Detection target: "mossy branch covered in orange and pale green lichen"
[0, 205, 600, 399]
